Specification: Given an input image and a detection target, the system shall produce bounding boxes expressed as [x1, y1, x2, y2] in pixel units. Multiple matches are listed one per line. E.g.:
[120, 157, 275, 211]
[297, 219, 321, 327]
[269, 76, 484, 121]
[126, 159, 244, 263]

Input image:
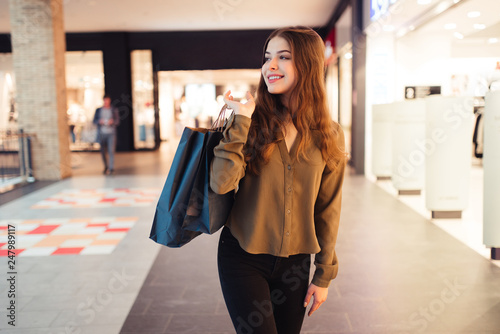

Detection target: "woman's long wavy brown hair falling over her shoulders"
[244, 27, 346, 174]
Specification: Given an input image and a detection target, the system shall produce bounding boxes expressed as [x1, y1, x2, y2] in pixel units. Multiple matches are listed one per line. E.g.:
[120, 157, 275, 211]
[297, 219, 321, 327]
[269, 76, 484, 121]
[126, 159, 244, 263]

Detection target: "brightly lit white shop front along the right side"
[365, 0, 500, 257]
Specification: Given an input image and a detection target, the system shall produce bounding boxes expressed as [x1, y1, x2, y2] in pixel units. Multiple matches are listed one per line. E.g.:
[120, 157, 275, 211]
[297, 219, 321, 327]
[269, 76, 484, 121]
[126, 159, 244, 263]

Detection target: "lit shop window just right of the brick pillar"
[66, 51, 104, 151]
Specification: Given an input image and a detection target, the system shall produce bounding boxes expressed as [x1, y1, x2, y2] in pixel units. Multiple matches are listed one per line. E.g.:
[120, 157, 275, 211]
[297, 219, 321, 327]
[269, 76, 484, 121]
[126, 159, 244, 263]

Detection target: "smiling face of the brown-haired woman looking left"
[262, 36, 296, 96]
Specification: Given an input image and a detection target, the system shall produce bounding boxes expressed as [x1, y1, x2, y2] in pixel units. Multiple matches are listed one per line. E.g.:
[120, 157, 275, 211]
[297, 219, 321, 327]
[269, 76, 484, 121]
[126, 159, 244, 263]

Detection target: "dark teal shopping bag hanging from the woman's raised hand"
[150, 108, 234, 247]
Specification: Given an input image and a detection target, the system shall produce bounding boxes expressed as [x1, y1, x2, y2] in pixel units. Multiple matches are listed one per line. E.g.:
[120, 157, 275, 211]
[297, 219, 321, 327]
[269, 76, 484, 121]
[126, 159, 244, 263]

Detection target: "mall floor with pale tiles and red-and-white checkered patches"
[0, 145, 500, 334]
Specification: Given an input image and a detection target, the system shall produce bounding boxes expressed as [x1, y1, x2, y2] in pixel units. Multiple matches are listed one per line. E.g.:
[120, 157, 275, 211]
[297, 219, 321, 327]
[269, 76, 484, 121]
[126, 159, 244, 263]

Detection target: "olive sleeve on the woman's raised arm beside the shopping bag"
[210, 115, 251, 194]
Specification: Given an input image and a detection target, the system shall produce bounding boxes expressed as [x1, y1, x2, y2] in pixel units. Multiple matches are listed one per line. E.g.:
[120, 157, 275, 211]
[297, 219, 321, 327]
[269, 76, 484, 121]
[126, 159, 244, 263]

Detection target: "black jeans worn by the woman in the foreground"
[217, 227, 311, 334]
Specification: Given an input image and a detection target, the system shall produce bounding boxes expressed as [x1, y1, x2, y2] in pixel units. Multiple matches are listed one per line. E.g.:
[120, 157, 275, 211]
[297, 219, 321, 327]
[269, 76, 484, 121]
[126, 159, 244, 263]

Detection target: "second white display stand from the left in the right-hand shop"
[392, 99, 425, 195]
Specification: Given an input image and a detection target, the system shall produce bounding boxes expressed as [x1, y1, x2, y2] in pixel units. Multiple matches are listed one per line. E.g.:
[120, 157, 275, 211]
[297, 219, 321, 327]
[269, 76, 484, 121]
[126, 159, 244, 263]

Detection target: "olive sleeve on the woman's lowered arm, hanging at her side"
[312, 127, 345, 287]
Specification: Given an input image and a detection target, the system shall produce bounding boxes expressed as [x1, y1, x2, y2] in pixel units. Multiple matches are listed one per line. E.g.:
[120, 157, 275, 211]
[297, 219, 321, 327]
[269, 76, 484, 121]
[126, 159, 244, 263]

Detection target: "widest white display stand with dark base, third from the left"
[419, 96, 474, 218]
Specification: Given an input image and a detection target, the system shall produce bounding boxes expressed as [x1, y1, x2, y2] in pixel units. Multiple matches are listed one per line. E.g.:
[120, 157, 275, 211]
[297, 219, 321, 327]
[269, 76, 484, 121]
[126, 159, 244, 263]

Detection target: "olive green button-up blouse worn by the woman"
[210, 115, 345, 287]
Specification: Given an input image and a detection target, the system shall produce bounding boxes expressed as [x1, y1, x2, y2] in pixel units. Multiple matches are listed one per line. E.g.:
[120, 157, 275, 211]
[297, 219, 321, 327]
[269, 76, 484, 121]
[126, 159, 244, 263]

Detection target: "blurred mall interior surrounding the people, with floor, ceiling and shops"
[0, 0, 500, 334]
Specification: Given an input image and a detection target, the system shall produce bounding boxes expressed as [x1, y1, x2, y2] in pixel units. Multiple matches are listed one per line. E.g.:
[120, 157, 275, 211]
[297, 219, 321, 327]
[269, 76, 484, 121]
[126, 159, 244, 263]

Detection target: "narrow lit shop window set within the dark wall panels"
[131, 50, 155, 149]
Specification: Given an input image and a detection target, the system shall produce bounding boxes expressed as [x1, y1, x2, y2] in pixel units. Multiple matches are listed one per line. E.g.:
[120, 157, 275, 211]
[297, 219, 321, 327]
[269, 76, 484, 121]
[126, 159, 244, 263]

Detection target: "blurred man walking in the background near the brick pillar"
[94, 94, 120, 174]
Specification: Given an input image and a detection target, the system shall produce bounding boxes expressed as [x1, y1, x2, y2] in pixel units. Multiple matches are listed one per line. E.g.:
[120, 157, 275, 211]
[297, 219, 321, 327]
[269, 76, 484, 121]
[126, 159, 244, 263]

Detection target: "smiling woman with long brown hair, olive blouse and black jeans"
[210, 27, 347, 334]
